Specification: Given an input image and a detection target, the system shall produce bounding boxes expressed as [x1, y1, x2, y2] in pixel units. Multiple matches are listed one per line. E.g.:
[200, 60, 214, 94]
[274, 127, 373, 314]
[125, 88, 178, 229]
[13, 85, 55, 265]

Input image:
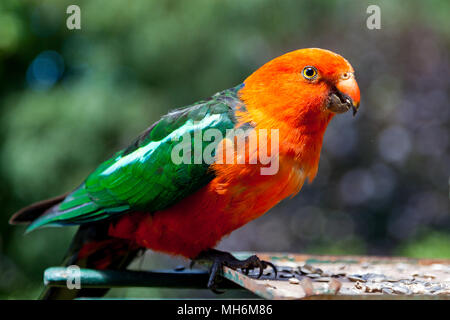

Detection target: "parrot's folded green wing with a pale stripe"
[27, 85, 242, 231]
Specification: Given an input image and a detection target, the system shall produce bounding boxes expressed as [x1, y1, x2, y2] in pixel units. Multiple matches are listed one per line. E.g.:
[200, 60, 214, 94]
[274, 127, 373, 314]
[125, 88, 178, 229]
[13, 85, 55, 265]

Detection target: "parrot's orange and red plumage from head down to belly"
[109, 49, 360, 258]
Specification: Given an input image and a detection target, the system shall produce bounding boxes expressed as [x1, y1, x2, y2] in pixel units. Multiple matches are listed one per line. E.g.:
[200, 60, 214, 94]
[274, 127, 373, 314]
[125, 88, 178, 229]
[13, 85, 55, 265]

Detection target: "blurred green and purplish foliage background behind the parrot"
[0, 0, 450, 298]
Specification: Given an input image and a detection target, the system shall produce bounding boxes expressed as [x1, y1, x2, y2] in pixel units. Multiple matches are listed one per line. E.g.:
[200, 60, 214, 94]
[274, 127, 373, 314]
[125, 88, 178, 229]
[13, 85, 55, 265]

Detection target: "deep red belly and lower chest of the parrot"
[125, 156, 304, 258]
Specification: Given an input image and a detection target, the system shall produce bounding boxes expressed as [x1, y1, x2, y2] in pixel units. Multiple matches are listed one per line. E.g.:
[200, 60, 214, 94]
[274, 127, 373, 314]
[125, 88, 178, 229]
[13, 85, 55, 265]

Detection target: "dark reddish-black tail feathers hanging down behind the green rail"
[39, 222, 141, 300]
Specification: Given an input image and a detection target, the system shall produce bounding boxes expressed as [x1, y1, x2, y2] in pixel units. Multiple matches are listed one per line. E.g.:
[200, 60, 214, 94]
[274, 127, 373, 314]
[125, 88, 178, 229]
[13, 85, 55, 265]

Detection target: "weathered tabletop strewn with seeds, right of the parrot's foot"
[223, 253, 450, 299]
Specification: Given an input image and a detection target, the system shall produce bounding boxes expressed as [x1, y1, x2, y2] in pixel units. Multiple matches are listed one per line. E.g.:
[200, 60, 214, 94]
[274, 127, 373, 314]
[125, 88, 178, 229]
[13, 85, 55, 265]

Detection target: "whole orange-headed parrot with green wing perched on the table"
[10, 48, 360, 299]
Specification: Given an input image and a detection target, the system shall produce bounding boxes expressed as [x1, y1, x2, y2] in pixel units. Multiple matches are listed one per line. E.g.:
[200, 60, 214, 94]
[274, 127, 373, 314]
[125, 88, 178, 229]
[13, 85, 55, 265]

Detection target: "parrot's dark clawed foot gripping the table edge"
[191, 249, 277, 293]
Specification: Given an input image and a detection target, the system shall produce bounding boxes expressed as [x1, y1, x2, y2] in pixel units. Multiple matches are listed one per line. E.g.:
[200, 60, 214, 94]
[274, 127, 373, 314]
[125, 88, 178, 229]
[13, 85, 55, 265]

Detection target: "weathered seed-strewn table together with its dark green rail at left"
[44, 252, 450, 299]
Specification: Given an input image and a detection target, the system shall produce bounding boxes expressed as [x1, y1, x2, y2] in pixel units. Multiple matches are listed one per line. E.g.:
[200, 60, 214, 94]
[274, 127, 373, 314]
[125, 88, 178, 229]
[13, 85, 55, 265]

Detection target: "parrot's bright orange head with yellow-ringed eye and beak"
[240, 48, 359, 128]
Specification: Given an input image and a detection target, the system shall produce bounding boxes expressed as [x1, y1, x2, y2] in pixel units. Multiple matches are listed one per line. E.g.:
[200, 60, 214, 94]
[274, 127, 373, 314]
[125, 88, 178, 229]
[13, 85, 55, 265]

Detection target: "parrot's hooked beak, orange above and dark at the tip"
[327, 77, 359, 115]
